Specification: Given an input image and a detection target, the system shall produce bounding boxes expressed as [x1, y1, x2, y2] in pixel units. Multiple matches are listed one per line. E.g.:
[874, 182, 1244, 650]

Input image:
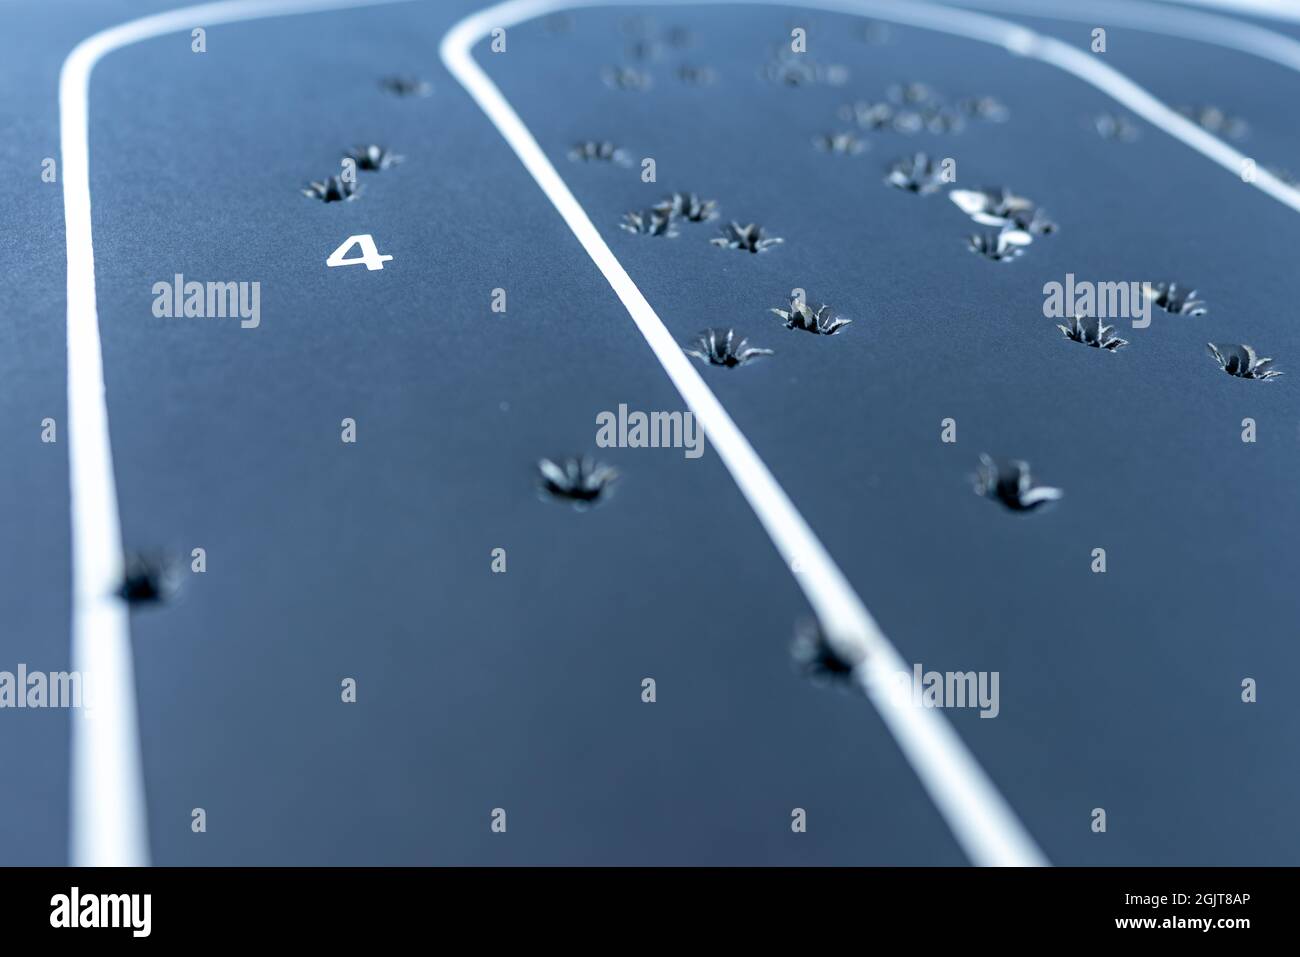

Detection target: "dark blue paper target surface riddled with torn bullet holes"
[0, 4, 1300, 863]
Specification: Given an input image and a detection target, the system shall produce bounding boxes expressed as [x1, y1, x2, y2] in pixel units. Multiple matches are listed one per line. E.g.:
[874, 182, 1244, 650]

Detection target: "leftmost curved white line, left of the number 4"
[59, 0, 410, 866]
